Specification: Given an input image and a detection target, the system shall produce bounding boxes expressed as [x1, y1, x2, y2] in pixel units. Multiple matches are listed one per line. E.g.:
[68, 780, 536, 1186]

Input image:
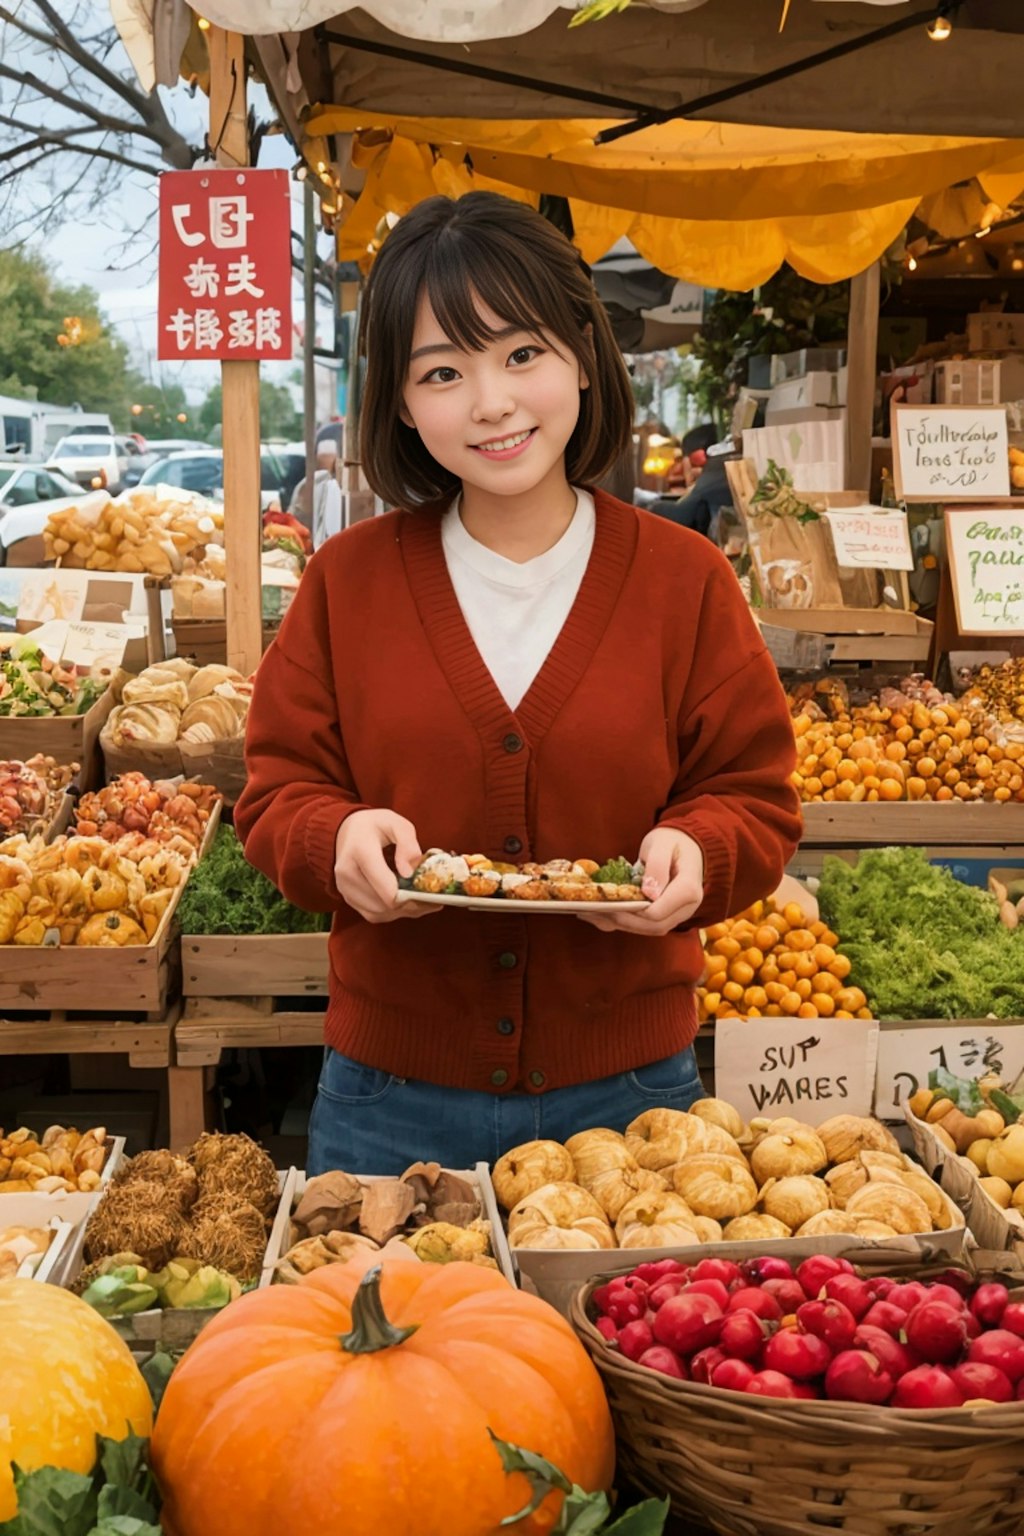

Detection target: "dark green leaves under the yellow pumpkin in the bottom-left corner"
[0, 1435, 160, 1536]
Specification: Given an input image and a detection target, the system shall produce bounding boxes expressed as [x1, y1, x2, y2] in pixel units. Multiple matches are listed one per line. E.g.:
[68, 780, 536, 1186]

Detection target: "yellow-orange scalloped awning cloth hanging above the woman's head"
[306, 106, 1024, 289]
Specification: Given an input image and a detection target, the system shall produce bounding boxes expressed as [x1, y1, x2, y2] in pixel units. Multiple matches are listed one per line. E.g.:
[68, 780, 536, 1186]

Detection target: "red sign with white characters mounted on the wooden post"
[157, 169, 292, 362]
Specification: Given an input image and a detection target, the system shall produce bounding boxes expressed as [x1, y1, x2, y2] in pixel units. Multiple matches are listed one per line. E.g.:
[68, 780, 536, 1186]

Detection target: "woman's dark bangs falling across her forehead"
[421, 230, 586, 355]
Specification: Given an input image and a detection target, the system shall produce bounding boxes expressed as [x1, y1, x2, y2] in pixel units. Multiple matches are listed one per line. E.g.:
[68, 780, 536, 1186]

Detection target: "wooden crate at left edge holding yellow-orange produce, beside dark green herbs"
[0, 800, 221, 1013]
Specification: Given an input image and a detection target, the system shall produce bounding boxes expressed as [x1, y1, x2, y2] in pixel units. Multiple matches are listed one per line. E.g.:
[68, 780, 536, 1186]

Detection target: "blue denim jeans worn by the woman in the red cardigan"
[306, 1046, 705, 1177]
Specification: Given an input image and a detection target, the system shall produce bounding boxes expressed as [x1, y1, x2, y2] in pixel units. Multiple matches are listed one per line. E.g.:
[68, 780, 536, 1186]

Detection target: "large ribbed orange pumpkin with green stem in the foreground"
[152, 1253, 614, 1536]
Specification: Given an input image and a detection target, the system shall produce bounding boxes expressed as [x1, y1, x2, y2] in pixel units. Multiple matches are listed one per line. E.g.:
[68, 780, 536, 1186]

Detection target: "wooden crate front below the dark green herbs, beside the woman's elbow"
[181, 934, 329, 998]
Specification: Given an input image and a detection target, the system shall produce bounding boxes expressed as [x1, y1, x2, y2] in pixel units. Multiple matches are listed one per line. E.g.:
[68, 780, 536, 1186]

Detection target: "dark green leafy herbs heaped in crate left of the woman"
[178, 826, 330, 934]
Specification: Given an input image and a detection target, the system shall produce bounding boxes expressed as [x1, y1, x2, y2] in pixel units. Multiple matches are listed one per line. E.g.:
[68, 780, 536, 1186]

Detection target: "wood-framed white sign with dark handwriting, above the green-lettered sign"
[892, 406, 1010, 502]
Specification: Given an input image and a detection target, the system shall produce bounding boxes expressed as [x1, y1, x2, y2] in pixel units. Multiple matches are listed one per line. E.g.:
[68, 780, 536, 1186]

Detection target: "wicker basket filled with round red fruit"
[573, 1255, 1024, 1536]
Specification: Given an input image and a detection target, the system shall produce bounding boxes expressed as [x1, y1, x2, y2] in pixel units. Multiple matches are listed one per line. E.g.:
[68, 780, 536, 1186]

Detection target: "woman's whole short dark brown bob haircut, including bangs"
[359, 192, 634, 507]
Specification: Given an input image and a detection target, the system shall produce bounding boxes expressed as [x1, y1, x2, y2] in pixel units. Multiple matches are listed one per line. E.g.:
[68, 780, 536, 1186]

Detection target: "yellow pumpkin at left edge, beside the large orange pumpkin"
[0, 1279, 154, 1522]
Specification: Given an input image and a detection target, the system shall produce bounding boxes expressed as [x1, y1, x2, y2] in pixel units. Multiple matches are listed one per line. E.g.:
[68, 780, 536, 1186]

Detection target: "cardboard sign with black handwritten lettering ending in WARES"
[715, 1018, 878, 1126]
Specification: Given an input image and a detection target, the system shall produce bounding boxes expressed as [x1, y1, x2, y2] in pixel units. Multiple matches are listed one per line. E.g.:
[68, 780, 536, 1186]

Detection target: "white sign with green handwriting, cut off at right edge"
[946, 507, 1024, 636]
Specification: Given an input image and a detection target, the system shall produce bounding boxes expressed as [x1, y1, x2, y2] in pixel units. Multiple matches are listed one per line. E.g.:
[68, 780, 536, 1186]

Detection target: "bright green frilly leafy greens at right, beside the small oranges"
[818, 848, 1024, 1018]
